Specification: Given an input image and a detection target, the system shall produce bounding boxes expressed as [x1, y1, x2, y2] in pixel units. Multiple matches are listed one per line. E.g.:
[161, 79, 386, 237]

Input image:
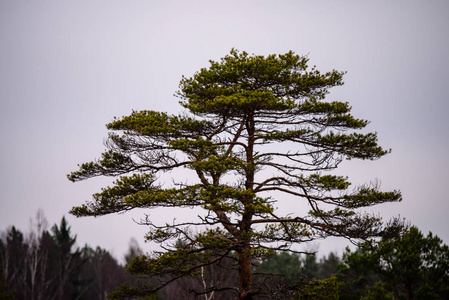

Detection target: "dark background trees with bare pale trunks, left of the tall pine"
[0, 211, 131, 300]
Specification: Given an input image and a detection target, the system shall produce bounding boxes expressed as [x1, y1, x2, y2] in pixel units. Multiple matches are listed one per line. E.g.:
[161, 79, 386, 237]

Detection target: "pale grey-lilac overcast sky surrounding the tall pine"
[0, 0, 449, 259]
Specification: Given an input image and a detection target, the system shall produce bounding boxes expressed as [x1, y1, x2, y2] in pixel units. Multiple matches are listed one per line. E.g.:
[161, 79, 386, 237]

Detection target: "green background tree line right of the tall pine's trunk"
[261, 226, 449, 300]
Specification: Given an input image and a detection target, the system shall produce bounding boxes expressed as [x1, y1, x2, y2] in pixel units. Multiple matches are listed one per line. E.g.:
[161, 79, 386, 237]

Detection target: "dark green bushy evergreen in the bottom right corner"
[339, 227, 449, 300]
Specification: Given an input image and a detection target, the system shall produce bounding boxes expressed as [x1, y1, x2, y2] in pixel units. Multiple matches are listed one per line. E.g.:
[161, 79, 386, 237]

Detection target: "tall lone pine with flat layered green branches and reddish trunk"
[68, 49, 402, 299]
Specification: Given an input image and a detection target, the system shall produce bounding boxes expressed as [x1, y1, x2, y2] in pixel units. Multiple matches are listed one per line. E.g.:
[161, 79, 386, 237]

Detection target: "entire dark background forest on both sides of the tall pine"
[0, 212, 449, 300]
